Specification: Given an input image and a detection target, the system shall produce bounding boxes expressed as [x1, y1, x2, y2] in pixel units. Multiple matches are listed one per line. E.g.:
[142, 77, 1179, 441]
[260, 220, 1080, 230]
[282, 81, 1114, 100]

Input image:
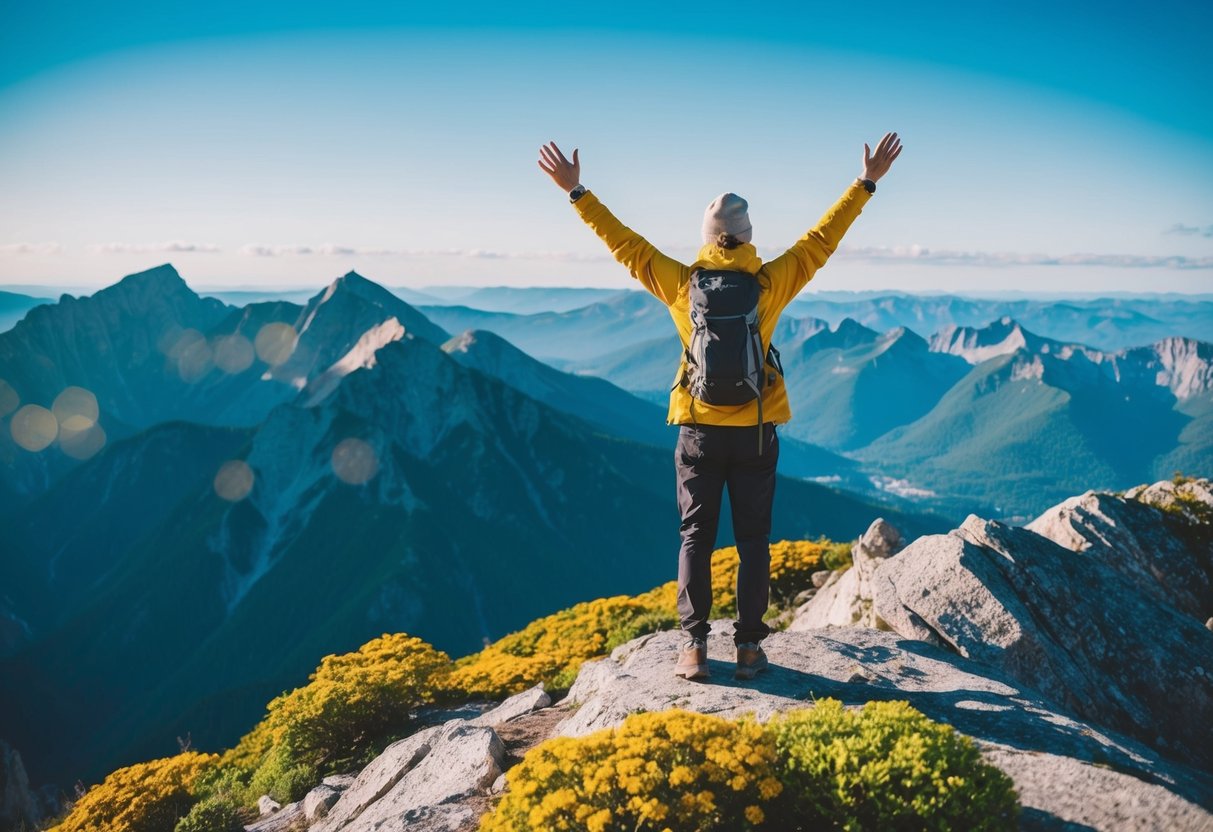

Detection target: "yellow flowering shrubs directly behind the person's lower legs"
[448, 540, 848, 699]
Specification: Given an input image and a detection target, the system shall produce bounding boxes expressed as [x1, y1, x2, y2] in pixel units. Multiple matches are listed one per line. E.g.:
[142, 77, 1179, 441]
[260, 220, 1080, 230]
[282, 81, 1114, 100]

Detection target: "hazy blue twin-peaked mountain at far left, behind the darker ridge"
[0, 266, 450, 505]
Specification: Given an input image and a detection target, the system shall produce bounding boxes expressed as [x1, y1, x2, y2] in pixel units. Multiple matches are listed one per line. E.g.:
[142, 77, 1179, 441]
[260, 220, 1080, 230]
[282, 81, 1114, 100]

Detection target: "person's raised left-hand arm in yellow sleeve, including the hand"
[539, 142, 689, 306]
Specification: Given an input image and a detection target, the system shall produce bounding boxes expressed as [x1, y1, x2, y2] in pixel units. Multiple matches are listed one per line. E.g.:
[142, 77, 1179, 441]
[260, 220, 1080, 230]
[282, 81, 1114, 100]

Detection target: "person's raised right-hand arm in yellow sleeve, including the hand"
[767, 133, 901, 309]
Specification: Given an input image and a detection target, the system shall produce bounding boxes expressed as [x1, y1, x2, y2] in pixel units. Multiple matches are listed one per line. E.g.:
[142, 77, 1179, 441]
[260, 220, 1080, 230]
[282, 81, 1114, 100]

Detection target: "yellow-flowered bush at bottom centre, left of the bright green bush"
[480, 708, 782, 832]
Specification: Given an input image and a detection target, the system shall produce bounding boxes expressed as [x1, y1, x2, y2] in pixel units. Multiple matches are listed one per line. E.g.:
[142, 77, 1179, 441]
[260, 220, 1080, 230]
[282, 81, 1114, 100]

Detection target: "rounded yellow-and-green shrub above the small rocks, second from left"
[223, 633, 451, 799]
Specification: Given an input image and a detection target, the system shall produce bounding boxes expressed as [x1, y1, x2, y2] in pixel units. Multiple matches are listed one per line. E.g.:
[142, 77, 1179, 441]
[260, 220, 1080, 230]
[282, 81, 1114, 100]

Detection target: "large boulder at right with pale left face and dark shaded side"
[873, 514, 1213, 768]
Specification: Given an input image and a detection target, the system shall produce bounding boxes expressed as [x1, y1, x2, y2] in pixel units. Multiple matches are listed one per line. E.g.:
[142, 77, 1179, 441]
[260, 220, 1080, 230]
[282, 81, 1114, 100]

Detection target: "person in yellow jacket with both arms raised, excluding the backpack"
[539, 132, 901, 679]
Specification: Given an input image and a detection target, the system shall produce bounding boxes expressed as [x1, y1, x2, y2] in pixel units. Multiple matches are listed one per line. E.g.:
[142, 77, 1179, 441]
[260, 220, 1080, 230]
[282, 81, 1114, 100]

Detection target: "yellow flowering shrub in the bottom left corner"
[51, 751, 218, 832]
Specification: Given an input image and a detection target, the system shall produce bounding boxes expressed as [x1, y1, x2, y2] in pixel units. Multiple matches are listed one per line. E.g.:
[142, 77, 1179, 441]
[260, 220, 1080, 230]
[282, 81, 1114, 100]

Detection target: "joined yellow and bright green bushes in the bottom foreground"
[480, 699, 1019, 832]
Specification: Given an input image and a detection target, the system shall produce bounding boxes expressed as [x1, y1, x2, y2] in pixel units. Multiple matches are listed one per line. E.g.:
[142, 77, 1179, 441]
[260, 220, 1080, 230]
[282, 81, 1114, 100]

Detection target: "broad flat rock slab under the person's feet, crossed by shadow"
[556, 620, 1213, 830]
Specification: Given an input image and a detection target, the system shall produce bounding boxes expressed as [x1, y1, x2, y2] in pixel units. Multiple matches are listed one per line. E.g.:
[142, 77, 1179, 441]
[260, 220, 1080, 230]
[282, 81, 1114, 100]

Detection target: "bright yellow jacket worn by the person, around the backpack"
[573, 181, 871, 427]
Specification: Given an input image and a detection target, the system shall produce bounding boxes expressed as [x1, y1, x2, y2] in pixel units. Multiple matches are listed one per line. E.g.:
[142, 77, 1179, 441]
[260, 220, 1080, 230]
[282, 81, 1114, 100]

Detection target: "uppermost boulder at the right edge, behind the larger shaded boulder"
[1025, 489, 1213, 621]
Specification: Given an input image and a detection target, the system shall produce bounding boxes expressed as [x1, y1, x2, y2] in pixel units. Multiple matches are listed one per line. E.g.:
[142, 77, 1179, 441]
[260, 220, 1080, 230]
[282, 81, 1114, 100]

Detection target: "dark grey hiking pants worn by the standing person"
[674, 422, 779, 644]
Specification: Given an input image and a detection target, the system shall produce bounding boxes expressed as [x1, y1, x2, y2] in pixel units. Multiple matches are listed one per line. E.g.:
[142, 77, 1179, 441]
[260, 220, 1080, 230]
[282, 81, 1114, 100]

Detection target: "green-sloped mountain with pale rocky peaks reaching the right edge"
[855, 329, 1213, 518]
